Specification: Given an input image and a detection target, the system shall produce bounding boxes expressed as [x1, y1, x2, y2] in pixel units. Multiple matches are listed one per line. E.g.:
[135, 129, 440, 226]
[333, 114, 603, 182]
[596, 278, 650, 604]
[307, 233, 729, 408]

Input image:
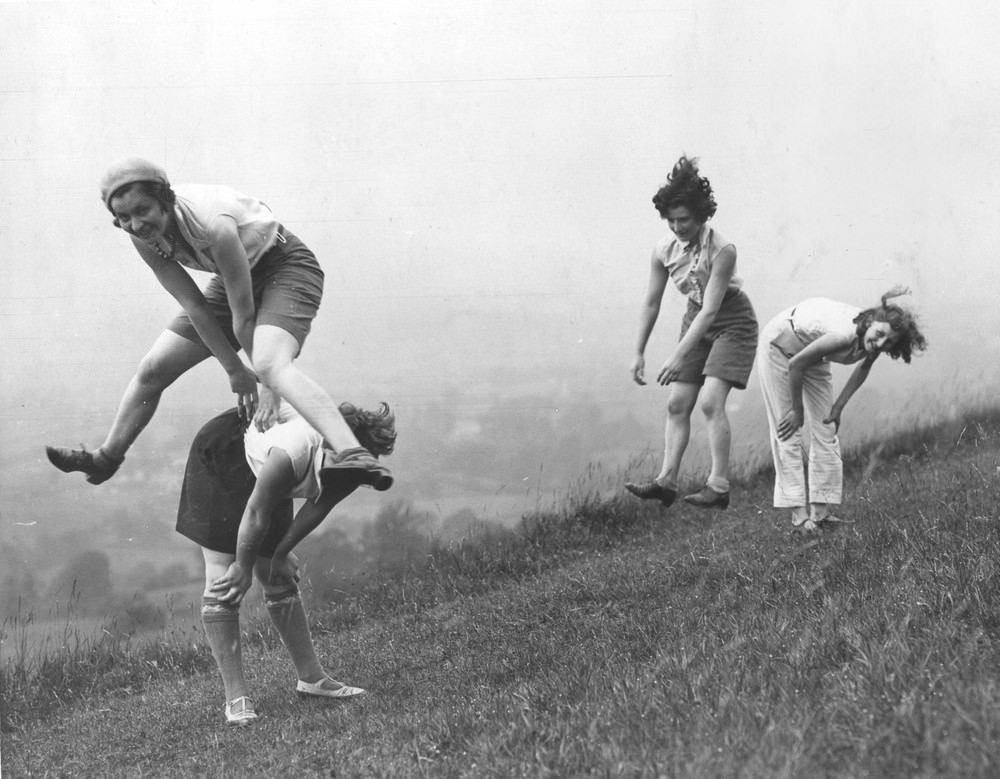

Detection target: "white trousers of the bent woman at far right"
[757, 318, 844, 508]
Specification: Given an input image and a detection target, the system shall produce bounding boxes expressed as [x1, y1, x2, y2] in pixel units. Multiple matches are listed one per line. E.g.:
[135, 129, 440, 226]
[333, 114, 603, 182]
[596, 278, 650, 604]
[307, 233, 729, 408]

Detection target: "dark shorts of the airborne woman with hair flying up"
[677, 290, 757, 389]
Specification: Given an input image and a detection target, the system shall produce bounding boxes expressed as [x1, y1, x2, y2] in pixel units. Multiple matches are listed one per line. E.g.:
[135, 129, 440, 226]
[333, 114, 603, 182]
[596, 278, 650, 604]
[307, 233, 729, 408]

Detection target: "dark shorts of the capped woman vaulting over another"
[167, 227, 323, 351]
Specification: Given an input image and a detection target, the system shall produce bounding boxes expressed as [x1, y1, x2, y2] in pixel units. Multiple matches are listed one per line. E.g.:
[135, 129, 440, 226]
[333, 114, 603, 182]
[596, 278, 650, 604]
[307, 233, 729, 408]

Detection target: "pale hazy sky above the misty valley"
[0, 0, 1000, 516]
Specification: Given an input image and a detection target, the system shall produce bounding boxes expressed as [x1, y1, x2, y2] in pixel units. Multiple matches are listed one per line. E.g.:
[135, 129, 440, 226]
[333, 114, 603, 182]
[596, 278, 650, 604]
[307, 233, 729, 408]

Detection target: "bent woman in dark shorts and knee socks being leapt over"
[176, 391, 396, 725]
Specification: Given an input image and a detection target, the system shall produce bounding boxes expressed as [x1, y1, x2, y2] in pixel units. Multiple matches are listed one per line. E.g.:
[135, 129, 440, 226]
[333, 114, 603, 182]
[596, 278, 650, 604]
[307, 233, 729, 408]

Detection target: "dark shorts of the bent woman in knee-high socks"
[175, 409, 292, 557]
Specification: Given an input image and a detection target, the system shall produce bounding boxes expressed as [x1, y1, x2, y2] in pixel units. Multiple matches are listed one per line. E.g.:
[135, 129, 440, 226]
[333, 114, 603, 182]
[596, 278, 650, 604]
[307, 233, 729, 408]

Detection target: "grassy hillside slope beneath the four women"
[3, 417, 1000, 777]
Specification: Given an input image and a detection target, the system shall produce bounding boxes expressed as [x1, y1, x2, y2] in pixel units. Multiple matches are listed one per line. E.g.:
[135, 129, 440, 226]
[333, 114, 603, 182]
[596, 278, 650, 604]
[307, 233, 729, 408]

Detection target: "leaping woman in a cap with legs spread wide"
[46, 158, 393, 490]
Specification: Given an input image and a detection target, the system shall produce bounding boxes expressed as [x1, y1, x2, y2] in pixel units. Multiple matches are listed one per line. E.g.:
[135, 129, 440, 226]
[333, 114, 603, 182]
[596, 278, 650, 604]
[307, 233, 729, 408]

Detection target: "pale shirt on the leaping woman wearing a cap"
[167, 184, 280, 273]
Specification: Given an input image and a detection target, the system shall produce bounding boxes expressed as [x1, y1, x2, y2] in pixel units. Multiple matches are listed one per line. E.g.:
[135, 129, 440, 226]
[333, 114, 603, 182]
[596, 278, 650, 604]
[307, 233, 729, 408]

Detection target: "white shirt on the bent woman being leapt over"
[245, 400, 323, 498]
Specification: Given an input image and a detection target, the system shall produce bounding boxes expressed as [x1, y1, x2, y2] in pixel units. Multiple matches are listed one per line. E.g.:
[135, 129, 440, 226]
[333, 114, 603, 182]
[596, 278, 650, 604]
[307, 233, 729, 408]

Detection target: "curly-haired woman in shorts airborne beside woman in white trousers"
[625, 157, 757, 509]
